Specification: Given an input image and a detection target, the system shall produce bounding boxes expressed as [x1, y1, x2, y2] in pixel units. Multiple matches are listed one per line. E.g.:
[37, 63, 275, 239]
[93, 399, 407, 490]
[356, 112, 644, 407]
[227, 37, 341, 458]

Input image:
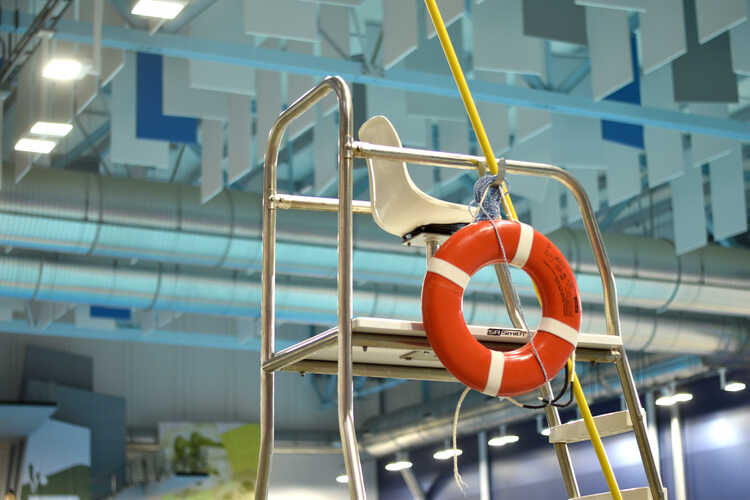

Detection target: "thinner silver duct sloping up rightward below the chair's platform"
[361, 357, 707, 457]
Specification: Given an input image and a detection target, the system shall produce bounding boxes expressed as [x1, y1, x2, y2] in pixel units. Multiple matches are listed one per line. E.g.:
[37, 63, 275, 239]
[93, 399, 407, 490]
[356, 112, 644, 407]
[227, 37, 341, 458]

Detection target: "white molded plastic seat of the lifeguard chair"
[359, 115, 472, 237]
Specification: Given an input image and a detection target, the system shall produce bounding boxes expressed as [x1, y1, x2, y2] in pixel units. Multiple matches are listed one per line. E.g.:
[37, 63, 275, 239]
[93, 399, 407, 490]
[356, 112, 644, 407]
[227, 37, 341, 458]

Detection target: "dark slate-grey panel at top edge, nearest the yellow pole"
[523, 0, 587, 45]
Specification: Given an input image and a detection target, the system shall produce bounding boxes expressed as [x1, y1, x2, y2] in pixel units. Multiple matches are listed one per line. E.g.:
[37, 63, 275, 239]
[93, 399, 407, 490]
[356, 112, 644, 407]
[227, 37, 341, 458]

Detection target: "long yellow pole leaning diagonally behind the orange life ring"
[425, 0, 622, 500]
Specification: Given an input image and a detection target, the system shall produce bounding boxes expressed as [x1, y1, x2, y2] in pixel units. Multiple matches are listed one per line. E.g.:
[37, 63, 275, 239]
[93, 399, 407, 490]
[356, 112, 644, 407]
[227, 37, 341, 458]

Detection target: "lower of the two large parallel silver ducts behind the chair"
[0, 255, 750, 355]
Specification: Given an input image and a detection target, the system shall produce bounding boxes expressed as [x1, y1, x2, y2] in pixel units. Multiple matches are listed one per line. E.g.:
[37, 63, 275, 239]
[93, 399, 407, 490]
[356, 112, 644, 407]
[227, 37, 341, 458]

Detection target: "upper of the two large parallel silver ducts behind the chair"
[0, 169, 750, 316]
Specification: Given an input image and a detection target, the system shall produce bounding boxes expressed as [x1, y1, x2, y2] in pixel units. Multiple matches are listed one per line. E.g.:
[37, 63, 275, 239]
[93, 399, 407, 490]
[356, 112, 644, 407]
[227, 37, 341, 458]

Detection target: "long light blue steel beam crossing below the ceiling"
[0, 14, 750, 142]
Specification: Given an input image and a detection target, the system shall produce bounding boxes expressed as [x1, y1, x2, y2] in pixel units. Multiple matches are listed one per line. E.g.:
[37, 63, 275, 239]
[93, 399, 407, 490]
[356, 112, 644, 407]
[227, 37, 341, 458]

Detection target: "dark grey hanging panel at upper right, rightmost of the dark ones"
[672, 0, 738, 102]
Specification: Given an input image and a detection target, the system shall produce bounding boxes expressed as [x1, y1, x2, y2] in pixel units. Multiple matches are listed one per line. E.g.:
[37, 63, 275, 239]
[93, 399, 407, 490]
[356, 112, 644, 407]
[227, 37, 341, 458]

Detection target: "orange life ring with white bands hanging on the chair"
[422, 221, 581, 396]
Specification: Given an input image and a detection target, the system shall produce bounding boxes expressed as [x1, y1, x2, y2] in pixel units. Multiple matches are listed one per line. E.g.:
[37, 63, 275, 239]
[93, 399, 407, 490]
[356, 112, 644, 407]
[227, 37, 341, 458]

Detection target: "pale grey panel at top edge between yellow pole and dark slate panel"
[472, 0, 546, 78]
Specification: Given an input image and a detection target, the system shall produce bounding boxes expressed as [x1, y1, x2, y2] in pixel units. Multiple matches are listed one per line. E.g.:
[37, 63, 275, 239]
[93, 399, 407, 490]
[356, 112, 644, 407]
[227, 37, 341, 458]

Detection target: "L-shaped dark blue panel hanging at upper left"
[135, 52, 198, 143]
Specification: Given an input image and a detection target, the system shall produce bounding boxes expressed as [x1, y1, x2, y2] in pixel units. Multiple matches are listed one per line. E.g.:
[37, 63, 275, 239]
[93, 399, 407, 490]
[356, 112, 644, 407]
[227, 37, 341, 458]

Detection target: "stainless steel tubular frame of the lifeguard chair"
[255, 76, 666, 500]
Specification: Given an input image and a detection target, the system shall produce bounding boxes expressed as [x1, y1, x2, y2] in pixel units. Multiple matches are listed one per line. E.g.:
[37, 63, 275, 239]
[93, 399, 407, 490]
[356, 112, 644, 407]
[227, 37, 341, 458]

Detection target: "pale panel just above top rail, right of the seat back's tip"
[366, 85, 432, 147]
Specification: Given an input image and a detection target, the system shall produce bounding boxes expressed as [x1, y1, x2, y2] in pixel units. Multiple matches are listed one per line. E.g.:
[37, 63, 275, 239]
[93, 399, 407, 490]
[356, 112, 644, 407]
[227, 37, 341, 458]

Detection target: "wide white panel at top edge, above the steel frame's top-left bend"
[245, 0, 318, 42]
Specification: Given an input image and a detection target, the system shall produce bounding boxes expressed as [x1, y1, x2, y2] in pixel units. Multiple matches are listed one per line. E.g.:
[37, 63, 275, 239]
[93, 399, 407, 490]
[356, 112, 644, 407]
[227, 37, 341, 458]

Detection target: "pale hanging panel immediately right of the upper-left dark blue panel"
[162, 57, 229, 120]
